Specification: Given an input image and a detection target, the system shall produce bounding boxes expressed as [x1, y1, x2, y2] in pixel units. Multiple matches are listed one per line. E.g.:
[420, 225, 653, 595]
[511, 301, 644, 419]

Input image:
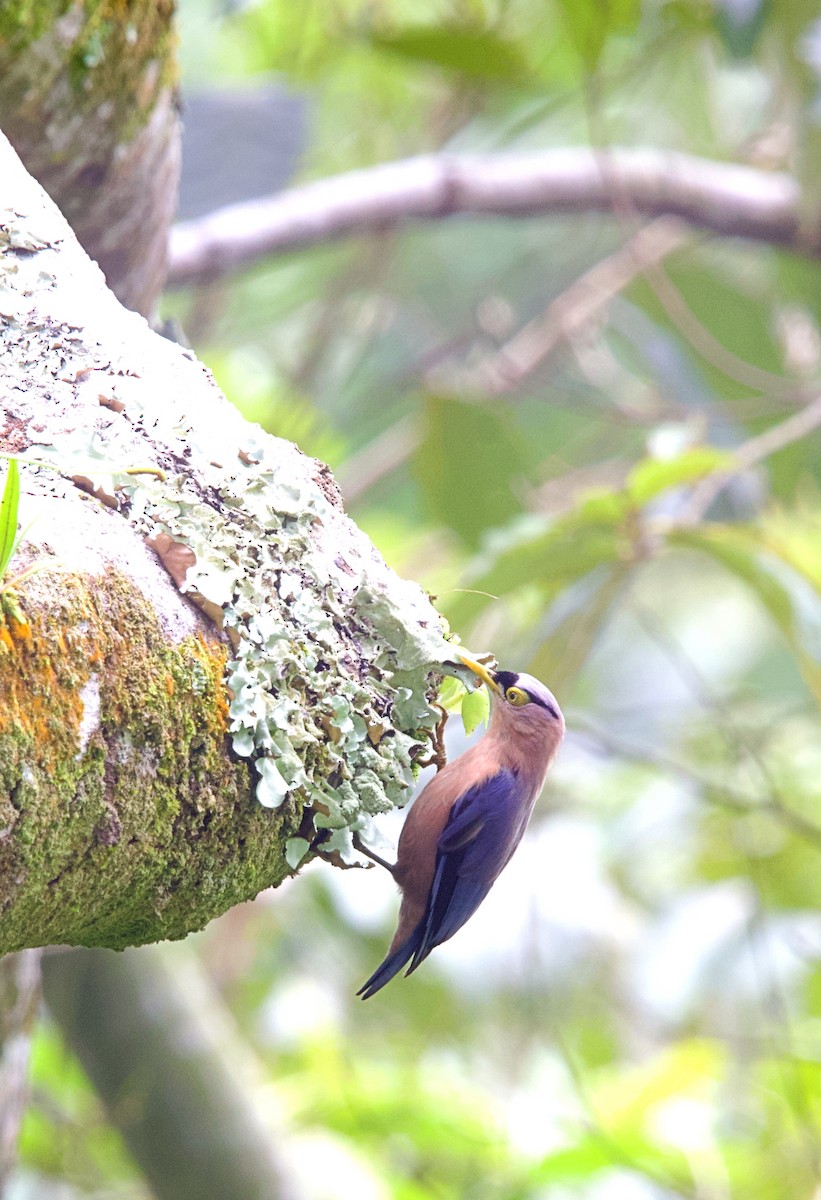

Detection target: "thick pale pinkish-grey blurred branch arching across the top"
[169, 148, 801, 286]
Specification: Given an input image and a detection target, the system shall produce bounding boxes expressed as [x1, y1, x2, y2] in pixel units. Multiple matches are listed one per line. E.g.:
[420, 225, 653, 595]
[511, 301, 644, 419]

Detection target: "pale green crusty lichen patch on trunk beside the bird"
[25, 391, 453, 860]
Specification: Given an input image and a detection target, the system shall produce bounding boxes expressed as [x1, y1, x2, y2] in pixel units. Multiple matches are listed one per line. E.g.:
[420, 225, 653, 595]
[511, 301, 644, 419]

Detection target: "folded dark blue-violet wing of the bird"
[408, 769, 523, 974]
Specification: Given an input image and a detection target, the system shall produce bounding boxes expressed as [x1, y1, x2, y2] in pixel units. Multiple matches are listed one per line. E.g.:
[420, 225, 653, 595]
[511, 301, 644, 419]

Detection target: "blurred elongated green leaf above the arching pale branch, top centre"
[368, 25, 531, 83]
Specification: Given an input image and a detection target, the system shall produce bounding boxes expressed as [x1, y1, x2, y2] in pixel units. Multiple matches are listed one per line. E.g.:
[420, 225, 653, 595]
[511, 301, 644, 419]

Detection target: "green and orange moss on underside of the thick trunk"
[0, 574, 300, 952]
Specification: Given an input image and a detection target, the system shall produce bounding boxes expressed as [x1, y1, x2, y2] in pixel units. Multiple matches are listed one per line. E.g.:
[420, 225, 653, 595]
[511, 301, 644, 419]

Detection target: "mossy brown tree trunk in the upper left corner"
[0, 0, 180, 316]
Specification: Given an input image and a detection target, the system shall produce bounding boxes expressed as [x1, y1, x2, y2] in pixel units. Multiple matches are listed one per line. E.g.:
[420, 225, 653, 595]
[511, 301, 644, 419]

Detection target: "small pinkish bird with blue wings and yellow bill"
[356, 652, 564, 1000]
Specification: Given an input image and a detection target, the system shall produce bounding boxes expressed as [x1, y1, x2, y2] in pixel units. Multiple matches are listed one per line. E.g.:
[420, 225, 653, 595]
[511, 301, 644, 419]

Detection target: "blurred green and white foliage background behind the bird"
[12, 0, 821, 1200]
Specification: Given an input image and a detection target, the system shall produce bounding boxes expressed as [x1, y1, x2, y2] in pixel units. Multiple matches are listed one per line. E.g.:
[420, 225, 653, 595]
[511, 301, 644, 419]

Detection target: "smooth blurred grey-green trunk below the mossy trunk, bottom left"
[43, 947, 300, 1200]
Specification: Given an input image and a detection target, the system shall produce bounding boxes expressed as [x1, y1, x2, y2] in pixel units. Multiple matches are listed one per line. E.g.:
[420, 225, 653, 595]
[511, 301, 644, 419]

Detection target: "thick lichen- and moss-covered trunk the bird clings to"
[0, 131, 453, 952]
